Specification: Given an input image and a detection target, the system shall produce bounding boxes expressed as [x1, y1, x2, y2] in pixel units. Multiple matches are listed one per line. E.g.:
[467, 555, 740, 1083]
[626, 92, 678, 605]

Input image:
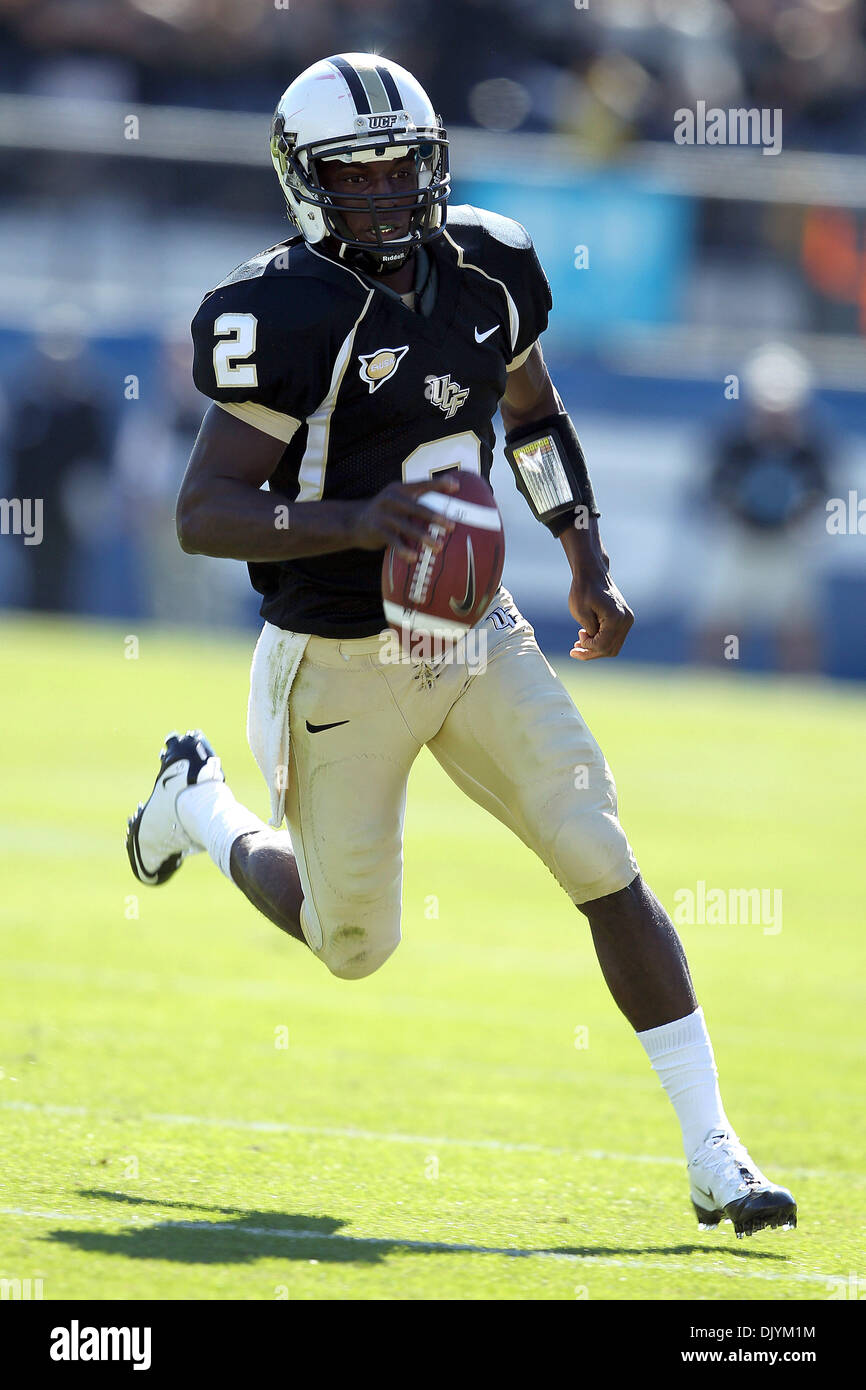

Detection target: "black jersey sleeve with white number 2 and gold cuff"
[192, 277, 337, 442]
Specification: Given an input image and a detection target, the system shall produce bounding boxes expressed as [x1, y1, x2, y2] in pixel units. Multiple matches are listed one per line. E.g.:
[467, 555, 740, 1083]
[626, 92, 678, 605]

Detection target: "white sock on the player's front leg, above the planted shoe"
[638, 1009, 734, 1159]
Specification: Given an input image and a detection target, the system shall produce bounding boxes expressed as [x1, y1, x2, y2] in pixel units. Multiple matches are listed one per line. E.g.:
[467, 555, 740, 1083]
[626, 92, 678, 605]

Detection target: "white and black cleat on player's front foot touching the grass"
[688, 1130, 796, 1237]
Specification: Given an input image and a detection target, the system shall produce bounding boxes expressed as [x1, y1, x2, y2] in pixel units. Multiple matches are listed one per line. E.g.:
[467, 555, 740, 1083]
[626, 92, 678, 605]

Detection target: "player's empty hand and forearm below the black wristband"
[563, 523, 634, 662]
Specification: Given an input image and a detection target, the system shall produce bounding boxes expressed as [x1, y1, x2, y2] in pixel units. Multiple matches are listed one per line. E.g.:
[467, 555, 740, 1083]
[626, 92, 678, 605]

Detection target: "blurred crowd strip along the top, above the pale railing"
[0, 0, 866, 152]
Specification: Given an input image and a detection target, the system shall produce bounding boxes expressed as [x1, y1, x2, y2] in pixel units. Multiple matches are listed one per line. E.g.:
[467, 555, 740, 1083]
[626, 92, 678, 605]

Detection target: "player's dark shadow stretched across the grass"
[32, 1190, 787, 1265]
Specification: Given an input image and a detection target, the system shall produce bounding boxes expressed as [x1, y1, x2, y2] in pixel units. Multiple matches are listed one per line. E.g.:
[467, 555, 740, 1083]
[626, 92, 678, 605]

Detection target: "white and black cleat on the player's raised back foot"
[126, 728, 225, 887]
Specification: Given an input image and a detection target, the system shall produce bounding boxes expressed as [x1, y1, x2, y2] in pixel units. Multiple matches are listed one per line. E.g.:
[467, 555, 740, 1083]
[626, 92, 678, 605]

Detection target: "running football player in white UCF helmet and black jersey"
[128, 53, 796, 1236]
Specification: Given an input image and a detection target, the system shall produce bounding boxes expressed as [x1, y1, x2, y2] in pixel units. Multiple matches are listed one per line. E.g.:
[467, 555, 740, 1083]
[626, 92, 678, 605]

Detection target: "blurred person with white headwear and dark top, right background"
[698, 343, 830, 671]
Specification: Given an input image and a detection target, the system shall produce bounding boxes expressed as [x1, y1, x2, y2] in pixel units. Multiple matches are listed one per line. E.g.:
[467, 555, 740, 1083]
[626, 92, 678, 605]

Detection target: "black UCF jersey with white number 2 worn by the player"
[192, 206, 552, 638]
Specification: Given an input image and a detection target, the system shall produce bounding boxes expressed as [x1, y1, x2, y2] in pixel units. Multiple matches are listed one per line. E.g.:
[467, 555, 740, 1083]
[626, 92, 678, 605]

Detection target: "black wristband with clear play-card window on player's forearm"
[505, 411, 601, 537]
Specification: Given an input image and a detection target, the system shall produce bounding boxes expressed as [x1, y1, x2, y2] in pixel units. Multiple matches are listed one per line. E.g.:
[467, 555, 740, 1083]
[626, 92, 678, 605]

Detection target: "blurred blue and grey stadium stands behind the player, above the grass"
[0, 0, 866, 678]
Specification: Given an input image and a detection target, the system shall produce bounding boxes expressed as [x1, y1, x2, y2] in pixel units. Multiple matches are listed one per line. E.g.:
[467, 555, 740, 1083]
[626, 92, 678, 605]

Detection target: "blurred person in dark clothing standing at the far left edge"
[7, 322, 111, 612]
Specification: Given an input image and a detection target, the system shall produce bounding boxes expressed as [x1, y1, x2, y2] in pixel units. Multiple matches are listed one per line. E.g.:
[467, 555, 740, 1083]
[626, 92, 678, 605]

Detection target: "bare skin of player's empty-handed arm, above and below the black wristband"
[499, 343, 634, 662]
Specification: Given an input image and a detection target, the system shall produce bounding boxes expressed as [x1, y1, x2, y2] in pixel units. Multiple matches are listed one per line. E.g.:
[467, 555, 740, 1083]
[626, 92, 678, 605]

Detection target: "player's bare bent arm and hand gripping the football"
[177, 404, 456, 562]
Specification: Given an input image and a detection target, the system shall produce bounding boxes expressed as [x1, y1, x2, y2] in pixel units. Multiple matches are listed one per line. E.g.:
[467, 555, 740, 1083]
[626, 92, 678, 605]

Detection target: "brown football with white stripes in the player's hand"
[382, 470, 505, 639]
